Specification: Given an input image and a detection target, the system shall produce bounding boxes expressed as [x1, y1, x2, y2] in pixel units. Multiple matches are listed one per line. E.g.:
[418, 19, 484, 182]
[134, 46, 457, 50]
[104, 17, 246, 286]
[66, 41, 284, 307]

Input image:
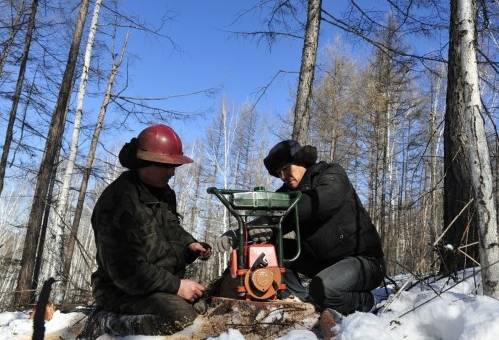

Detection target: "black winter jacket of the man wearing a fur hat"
[278, 162, 383, 266]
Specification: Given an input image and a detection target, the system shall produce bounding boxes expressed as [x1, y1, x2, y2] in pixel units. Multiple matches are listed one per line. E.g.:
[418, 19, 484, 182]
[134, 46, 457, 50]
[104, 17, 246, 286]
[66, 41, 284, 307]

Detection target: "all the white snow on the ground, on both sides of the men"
[0, 270, 499, 340]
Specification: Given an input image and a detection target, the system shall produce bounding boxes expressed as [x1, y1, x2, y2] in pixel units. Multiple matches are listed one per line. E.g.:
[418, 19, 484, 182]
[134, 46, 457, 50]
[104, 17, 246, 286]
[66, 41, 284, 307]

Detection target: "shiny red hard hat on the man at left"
[137, 124, 192, 165]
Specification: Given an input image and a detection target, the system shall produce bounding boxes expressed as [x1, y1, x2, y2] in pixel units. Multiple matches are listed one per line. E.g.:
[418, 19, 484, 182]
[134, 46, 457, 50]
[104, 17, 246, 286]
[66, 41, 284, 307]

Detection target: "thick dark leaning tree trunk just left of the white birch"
[13, 0, 89, 306]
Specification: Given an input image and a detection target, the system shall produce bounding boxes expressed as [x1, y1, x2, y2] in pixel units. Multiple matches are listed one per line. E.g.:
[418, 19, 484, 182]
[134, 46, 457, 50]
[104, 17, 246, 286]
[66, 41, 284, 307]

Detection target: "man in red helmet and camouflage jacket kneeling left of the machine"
[92, 124, 211, 332]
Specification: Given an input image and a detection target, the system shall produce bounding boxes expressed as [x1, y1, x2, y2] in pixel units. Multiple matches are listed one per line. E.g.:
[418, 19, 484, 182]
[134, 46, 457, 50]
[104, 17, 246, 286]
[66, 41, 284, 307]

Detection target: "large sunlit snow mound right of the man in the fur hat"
[335, 270, 499, 340]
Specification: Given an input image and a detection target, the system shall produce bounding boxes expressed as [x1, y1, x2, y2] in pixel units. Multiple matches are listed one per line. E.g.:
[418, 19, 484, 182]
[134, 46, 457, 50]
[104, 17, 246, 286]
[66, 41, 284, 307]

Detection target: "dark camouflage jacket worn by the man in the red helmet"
[92, 171, 197, 309]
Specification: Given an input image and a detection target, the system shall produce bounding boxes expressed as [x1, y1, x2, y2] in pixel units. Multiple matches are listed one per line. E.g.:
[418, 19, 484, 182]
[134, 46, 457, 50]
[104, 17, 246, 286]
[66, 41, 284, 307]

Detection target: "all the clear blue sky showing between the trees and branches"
[0, 0, 454, 166]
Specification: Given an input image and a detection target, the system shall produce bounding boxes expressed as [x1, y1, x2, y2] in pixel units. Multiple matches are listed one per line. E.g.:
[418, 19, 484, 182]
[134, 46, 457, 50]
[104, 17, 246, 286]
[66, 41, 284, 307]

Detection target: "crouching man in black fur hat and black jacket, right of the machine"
[214, 140, 385, 315]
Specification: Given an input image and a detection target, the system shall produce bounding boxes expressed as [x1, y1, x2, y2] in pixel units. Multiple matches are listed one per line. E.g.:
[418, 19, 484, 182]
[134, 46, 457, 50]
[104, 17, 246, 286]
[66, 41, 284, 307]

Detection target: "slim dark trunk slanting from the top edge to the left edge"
[0, 0, 38, 194]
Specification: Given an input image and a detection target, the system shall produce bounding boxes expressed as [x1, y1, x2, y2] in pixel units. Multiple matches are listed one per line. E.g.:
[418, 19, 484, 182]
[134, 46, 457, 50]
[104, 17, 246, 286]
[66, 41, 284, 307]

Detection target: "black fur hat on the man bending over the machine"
[263, 139, 317, 177]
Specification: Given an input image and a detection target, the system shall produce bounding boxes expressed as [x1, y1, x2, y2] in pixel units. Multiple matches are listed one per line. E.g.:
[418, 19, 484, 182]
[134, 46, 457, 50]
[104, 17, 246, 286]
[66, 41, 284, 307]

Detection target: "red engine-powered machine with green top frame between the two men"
[207, 187, 301, 301]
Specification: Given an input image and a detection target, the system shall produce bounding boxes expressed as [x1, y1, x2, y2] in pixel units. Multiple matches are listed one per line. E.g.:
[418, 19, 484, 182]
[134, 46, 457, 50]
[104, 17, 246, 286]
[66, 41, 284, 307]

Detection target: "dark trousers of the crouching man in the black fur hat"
[284, 256, 385, 315]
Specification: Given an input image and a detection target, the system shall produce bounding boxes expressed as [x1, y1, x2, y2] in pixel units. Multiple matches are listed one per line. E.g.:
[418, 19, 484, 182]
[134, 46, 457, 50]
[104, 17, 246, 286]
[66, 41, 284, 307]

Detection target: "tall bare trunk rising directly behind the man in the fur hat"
[292, 0, 322, 145]
